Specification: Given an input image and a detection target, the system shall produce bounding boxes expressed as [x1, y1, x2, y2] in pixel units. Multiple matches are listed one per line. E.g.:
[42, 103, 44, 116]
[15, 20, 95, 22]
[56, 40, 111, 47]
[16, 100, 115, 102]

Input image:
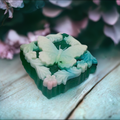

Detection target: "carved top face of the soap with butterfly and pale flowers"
[20, 33, 97, 85]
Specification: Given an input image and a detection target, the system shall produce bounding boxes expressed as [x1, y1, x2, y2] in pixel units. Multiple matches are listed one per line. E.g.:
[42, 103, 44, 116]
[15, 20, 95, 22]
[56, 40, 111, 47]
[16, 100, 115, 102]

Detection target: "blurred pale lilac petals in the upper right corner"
[88, 0, 120, 44]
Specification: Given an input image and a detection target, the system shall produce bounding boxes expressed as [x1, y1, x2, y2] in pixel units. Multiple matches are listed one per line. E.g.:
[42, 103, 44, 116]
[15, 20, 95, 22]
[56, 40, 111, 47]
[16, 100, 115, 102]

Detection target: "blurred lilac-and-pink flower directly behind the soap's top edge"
[53, 16, 88, 37]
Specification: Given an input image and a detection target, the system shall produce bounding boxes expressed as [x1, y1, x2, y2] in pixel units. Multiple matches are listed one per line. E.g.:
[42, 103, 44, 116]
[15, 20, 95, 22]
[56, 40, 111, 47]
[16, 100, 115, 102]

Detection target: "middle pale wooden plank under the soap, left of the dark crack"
[0, 46, 120, 119]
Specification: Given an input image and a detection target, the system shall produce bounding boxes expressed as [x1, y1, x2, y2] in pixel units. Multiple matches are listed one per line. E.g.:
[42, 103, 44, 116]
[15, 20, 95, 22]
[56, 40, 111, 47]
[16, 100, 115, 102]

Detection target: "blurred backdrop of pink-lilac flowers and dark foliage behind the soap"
[0, 0, 120, 59]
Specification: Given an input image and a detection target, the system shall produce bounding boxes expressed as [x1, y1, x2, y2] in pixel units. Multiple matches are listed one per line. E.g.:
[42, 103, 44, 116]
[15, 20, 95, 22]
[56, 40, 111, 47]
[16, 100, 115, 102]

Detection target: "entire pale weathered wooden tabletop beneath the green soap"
[0, 47, 120, 119]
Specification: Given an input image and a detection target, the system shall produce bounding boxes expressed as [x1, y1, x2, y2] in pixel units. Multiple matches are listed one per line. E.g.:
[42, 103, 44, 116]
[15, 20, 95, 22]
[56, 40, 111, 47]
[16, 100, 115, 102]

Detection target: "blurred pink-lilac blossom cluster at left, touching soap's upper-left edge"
[0, 22, 50, 59]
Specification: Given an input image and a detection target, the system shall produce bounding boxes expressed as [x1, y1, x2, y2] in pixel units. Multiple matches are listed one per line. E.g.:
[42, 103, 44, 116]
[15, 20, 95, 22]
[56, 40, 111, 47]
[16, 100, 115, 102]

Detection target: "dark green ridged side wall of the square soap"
[20, 50, 97, 99]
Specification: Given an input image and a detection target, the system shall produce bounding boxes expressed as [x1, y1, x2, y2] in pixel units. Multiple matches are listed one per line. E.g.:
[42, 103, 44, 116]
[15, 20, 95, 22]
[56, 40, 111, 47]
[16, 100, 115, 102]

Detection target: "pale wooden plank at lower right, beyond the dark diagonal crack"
[69, 66, 120, 119]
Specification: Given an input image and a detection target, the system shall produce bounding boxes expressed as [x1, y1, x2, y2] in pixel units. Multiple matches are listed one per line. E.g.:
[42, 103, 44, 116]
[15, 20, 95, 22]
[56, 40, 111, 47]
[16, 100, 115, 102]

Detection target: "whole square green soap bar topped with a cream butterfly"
[20, 33, 97, 99]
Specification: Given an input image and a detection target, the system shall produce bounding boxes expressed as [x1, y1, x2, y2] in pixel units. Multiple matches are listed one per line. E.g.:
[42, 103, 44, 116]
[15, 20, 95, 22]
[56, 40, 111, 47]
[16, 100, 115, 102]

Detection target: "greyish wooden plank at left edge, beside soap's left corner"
[0, 55, 26, 91]
